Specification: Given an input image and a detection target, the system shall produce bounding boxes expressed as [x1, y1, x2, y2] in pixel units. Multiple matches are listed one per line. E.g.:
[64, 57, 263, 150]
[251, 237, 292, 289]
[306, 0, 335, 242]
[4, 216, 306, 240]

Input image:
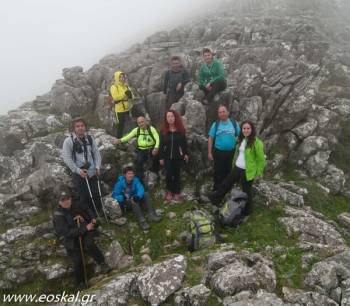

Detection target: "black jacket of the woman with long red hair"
[159, 132, 188, 159]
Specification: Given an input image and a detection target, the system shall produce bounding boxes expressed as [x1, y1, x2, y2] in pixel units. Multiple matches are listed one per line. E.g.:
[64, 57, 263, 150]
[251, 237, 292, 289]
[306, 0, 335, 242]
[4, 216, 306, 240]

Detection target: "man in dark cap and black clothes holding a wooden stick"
[53, 186, 111, 288]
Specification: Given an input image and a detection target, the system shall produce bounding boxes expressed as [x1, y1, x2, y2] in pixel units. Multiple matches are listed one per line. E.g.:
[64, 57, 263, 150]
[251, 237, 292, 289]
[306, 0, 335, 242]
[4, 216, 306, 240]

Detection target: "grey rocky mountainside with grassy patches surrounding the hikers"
[0, 0, 350, 306]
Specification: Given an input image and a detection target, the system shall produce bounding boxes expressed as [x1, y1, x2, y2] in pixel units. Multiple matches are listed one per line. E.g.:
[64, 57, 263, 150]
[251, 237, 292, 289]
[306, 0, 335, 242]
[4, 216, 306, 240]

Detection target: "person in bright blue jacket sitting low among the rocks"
[112, 165, 161, 231]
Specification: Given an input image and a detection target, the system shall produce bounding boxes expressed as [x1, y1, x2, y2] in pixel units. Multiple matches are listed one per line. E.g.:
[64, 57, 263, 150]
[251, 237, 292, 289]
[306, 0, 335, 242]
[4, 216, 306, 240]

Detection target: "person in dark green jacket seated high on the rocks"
[199, 48, 227, 127]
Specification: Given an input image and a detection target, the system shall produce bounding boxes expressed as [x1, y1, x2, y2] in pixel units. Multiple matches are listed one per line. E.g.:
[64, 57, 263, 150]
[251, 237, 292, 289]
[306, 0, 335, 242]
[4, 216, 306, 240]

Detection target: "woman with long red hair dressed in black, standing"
[159, 110, 188, 203]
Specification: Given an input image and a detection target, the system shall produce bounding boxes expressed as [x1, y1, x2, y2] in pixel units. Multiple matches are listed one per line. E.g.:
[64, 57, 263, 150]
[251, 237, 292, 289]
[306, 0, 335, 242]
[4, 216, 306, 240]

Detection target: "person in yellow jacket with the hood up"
[109, 70, 134, 138]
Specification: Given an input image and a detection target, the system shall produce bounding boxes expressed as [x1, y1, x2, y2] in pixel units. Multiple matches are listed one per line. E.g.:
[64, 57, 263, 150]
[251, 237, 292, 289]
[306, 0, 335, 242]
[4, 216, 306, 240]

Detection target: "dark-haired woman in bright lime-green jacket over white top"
[209, 120, 265, 215]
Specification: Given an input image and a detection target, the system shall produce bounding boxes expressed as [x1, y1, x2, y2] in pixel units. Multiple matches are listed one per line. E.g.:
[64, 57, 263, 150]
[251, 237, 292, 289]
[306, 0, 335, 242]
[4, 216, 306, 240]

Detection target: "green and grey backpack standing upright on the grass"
[189, 209, 215, 250]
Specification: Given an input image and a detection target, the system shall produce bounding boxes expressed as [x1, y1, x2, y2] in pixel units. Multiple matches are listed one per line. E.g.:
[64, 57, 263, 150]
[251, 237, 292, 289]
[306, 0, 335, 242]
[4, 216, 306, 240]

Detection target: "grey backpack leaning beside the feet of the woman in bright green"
[219, 189, 248, 226]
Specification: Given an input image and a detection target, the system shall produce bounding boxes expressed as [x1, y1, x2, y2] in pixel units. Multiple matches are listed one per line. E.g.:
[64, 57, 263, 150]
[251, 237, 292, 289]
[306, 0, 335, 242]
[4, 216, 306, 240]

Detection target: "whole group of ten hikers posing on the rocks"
[53, 48, 265, 286]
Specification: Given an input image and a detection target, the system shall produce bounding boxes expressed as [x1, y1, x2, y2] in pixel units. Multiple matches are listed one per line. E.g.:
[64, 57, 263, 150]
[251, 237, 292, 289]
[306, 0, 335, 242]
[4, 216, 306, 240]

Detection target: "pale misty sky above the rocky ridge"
[0, 0, 216, 114]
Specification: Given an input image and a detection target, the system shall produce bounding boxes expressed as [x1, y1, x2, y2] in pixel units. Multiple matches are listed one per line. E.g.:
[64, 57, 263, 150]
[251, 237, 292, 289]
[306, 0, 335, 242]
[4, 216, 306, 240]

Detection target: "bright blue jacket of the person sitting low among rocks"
[112, 175, 145, 203]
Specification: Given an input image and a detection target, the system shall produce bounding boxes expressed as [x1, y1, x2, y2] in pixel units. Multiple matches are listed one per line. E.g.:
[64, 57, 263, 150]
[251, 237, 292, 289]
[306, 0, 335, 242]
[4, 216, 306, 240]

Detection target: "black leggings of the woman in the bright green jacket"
[210, 166, 254, 215]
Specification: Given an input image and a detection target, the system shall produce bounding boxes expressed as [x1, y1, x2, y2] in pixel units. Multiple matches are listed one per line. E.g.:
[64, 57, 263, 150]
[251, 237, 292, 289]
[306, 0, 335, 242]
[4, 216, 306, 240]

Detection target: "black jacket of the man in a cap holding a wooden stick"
[53, 206, 87, 250]
